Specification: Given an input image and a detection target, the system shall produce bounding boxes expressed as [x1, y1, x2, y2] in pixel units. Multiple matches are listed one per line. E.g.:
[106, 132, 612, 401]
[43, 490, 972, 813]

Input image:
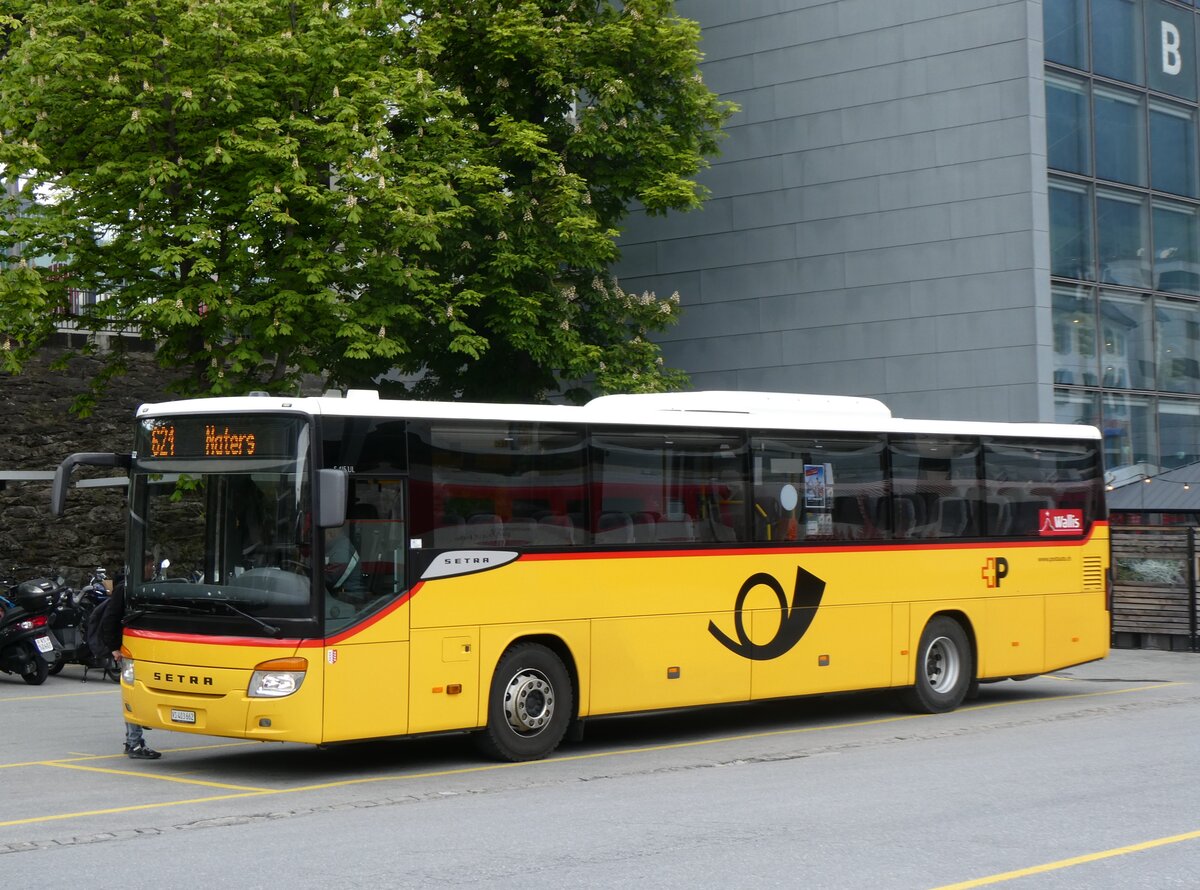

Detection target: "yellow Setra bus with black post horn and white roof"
[53, 391, 1110, 760]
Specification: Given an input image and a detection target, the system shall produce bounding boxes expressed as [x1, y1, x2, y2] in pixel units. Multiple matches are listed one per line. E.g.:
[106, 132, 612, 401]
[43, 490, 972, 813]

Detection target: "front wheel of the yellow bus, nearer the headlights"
[476, 643, 575, 762]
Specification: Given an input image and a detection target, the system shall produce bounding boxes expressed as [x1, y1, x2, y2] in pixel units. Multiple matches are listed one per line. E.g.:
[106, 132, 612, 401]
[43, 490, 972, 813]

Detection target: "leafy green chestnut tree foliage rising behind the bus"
[0, 0, 731, 399]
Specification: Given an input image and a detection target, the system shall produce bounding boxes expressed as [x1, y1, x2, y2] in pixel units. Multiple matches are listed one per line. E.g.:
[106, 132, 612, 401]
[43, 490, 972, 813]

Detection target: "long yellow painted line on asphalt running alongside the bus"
[0, 681, 1188, 828]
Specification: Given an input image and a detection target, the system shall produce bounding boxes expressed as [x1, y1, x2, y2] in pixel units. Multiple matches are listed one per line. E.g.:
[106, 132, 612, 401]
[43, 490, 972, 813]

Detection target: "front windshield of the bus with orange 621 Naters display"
[127, 416, 317, 636]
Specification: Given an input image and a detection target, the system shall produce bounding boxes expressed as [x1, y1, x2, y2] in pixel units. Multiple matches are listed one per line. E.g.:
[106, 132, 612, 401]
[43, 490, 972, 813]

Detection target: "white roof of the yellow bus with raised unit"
[137, 390, 1100, 439]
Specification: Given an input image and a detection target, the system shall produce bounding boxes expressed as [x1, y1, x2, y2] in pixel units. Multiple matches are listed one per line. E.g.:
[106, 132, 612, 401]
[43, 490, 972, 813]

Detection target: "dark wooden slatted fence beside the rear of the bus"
[1112, 525, 1200, 651]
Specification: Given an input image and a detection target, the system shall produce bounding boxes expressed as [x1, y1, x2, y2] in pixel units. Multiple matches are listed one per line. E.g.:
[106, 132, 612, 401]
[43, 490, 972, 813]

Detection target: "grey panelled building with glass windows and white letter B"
[618, 0, 1200, 484]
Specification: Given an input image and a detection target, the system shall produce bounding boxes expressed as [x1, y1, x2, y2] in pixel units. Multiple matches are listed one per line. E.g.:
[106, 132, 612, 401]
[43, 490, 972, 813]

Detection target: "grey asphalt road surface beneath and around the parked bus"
[0, 651, 1200, 890]
